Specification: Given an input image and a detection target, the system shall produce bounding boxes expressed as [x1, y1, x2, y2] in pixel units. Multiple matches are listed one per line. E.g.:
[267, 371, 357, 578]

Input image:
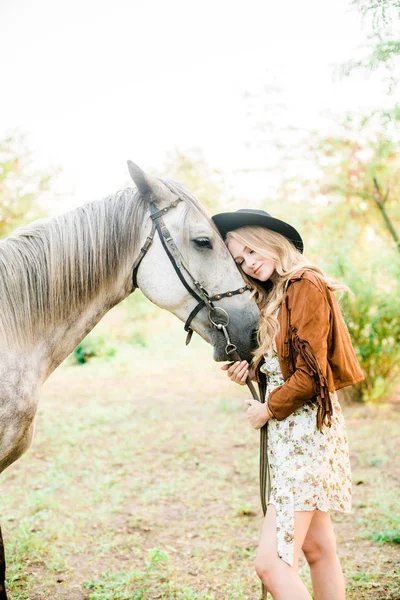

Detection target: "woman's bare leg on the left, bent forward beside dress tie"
[255, 504, 314, 600]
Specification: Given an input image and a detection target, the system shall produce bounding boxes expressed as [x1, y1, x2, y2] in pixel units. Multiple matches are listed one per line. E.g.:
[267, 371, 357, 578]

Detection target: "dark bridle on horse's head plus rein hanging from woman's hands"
[132, 198, 270, 593]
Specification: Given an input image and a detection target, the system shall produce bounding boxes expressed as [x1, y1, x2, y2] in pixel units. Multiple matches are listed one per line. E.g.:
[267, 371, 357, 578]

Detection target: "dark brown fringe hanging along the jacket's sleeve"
[290, 325, 333, 432]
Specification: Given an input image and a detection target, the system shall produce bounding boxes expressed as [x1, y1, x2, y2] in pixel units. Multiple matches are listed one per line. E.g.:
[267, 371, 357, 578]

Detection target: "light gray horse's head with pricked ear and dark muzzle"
[128, 161, 259, 361]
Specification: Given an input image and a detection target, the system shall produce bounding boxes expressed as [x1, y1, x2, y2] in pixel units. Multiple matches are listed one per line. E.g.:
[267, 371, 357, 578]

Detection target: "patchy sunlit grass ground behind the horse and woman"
[0, 308, 400, 600]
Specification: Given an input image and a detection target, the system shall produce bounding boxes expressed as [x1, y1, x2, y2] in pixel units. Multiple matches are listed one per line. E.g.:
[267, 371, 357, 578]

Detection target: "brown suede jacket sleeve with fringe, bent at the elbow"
[268, 279, 332, 429]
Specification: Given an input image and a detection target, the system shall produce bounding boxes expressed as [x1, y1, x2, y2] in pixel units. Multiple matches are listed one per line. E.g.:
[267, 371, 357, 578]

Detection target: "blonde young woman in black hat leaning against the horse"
[213, 209, 363, 600]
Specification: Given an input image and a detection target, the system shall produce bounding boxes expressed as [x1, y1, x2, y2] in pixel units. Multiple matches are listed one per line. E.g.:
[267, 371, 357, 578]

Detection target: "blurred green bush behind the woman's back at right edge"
[319, 236, 400, 401]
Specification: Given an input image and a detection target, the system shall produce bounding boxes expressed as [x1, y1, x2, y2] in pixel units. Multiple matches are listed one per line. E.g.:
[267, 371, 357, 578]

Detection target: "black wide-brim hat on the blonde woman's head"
[211, 208, 304, 253]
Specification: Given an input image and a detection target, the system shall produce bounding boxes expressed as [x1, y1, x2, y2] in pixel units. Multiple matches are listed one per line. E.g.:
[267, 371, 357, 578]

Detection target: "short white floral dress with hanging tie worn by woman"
[261, 354, 351, 566]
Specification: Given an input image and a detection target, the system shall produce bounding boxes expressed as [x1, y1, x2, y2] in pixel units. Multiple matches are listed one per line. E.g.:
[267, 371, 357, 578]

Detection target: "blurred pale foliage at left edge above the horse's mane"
[0, 135, 53, 238]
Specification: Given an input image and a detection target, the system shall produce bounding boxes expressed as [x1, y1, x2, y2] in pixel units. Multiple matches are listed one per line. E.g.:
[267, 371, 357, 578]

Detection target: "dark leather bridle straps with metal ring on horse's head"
[132, 198, 248, 356]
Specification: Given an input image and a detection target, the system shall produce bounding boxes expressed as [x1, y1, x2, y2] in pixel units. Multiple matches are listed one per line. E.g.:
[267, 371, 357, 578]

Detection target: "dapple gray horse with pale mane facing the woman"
[0, 163, 258, 600]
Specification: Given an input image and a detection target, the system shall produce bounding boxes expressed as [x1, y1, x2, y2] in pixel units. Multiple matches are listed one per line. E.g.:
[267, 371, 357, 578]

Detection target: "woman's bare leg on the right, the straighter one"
[303, 510, 346, 600]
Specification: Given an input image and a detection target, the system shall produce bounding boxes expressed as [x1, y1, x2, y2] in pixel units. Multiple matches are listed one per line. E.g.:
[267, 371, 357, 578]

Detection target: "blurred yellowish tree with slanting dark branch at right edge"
[311, 112, 400, 251]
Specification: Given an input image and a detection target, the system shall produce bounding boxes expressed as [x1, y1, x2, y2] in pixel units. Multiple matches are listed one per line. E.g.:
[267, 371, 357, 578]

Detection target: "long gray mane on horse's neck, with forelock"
[0, 180, 206, 345]
